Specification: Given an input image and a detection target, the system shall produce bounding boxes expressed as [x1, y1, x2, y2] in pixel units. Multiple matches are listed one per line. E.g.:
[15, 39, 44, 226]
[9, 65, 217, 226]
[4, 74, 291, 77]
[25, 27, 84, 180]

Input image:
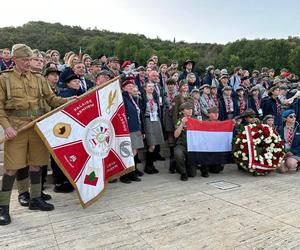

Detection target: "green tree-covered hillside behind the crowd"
[0, 22, 300, 74]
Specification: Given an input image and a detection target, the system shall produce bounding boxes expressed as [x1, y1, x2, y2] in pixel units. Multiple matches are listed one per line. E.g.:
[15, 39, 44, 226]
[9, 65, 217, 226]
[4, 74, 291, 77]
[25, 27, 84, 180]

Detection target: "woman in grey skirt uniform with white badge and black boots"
[141, 82, 164, 174]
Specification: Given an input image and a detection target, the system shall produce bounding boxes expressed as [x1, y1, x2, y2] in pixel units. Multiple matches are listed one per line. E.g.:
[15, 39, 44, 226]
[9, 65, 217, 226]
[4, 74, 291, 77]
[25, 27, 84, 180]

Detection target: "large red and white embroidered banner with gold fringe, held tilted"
[35, 80, 134, 207]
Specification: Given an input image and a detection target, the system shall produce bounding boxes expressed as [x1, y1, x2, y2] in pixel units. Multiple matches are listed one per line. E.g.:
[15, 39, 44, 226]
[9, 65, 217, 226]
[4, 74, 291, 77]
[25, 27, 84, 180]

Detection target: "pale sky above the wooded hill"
[0, 0, 300, 44]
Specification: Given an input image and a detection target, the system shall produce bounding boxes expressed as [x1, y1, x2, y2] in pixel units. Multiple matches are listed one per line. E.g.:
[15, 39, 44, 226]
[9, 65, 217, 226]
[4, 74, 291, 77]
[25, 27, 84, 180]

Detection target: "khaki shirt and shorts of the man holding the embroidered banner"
[0, 69, 67, 170]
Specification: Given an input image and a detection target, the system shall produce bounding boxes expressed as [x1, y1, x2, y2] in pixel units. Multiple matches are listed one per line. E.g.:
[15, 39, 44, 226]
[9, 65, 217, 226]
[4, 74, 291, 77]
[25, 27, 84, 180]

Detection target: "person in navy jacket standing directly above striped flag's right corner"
[219, 86, 239, 121]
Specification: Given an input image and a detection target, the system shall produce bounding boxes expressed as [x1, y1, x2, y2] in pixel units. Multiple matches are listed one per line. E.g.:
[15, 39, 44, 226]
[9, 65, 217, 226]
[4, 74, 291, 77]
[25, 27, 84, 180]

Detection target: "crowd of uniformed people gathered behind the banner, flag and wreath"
[0, 45, 300, 224]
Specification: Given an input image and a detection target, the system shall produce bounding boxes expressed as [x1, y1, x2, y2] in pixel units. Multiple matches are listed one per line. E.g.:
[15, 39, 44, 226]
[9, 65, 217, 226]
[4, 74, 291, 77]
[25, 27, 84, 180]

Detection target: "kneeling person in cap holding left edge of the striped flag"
[174, 102, 197, 181]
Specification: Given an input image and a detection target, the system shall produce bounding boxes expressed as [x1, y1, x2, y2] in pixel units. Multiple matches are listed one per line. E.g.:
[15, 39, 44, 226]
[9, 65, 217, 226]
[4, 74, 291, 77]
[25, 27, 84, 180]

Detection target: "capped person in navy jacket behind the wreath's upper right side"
[261, 86, 282, 128]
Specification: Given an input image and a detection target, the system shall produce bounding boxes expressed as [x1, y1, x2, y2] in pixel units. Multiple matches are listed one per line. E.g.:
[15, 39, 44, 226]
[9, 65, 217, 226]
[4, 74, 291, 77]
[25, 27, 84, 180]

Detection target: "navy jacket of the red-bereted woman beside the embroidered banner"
[122, 91, 143, 132]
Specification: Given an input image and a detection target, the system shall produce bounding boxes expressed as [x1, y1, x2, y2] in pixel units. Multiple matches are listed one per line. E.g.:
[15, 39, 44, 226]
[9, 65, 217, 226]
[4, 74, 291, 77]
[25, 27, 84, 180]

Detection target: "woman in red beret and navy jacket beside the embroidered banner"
[120, 77, 144, 183]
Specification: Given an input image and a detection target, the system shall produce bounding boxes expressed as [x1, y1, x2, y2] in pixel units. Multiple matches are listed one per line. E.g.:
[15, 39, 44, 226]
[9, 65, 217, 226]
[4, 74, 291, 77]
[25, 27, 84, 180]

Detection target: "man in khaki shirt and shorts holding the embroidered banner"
[0, 44, 67, 225]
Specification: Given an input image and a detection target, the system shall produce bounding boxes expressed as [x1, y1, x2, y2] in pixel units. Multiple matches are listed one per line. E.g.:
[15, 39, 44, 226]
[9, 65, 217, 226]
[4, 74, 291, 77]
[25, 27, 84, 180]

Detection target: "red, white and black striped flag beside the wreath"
[187, 119, 234, 165]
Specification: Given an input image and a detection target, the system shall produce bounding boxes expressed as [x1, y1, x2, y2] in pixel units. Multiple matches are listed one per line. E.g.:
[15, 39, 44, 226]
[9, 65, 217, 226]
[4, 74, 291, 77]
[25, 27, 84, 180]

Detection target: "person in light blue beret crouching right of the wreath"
[278, 109, 300, 173]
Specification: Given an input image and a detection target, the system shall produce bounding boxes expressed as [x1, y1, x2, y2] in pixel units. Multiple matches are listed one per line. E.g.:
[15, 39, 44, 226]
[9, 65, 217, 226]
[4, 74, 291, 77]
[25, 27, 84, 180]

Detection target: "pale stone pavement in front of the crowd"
[0, 162, 300, 250]
